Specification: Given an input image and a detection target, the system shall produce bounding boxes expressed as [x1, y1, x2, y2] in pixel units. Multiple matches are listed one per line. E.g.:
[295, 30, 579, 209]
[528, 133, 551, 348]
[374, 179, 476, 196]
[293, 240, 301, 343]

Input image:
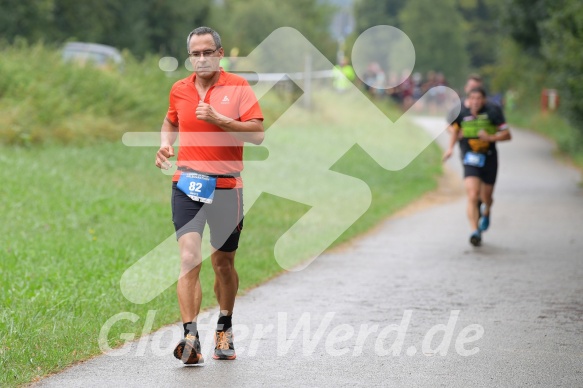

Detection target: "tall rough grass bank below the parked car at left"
[0, 43, 179, 145]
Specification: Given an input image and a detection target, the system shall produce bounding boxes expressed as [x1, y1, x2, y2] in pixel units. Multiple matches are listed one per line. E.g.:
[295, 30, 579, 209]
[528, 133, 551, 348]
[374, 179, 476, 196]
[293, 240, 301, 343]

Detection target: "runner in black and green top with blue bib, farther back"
[443, 88, 511, 246]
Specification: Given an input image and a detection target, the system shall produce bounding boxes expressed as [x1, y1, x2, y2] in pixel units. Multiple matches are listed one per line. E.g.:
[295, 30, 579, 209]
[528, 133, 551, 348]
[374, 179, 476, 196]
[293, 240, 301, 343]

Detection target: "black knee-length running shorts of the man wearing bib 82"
[172, 182, 243, 252]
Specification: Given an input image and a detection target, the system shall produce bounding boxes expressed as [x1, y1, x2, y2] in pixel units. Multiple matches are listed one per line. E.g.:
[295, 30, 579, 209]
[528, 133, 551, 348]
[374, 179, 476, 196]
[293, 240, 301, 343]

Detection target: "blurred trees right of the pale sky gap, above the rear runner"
[354, 0, 583, 132]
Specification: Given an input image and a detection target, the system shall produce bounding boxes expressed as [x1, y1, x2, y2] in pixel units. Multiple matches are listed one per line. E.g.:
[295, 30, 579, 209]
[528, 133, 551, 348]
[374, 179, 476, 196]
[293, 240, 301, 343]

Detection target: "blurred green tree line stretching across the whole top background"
[0, 0, 583, 132]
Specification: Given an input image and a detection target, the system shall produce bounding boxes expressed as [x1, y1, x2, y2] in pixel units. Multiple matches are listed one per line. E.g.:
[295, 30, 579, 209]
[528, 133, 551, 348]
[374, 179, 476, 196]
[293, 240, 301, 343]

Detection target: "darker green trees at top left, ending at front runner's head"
[0, 0, 212, 56]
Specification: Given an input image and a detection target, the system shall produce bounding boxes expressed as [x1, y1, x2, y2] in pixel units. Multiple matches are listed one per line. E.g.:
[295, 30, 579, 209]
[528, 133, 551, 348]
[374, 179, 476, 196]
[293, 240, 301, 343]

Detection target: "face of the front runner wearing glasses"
[189, 34, 224, 79]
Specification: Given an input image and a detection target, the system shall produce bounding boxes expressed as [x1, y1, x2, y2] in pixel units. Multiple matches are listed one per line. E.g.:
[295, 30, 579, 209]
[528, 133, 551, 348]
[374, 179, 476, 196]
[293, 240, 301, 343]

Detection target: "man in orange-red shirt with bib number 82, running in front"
[156, 27, 264, 364]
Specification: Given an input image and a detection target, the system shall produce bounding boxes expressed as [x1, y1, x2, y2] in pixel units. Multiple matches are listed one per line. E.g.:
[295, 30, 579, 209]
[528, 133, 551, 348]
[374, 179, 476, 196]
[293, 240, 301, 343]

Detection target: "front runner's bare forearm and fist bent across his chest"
[196, 101, 265, 145]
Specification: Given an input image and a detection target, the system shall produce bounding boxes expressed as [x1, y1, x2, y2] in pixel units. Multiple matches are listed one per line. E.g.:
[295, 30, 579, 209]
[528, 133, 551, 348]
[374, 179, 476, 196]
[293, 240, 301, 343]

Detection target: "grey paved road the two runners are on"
[38, 119, 583, 387]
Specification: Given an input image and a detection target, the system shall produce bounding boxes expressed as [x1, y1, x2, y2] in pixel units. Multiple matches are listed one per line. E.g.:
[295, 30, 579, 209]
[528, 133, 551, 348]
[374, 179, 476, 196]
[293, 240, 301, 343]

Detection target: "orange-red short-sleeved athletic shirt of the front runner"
[166, 68, 263, 188]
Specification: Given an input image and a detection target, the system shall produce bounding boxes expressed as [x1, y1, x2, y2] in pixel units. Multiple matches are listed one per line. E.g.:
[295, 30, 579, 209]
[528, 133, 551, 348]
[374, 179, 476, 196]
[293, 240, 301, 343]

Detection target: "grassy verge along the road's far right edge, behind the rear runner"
[507, 110, 583, 169]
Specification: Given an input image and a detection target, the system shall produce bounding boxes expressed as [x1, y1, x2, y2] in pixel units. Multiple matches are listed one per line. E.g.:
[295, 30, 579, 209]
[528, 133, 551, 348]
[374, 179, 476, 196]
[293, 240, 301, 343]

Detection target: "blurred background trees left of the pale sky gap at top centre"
[0, 0, 334, 57]
